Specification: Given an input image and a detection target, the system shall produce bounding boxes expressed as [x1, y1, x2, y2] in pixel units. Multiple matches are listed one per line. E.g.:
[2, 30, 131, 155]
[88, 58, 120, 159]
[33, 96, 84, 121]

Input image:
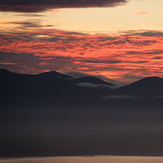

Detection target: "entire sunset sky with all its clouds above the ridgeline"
[0, 0, 163, 83]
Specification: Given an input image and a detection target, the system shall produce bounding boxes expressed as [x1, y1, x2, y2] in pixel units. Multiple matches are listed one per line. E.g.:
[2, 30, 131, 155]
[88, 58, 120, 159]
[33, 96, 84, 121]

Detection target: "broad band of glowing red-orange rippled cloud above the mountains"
[0, 29, 163, 82]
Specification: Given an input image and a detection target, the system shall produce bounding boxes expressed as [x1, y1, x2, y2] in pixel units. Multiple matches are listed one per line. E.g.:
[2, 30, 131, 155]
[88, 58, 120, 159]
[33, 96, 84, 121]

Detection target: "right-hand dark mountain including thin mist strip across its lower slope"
[105, 76, 163, 108]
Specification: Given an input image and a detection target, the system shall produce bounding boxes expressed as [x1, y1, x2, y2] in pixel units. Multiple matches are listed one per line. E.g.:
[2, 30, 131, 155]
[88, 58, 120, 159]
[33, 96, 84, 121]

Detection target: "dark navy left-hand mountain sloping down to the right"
[0, 69, 102, 105]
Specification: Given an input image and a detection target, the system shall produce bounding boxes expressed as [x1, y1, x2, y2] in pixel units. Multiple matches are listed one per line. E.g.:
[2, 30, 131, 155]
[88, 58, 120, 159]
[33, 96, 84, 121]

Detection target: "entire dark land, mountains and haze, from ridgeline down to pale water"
[0, 69, 163, 157]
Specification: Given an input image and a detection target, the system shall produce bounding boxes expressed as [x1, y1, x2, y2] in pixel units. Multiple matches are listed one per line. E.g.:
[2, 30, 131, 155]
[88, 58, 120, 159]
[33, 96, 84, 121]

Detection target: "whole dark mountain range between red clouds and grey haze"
[0, 69, 163, 105]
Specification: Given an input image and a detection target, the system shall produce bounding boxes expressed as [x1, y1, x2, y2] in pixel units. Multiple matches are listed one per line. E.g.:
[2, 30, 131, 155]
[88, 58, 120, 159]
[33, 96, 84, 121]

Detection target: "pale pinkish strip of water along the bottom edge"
[0, 156, 163, 163]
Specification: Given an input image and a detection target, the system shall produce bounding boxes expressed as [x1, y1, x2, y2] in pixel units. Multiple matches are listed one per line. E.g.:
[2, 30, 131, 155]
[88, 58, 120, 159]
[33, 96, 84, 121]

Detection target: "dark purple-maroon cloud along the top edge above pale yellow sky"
[0, 0, 128, 12]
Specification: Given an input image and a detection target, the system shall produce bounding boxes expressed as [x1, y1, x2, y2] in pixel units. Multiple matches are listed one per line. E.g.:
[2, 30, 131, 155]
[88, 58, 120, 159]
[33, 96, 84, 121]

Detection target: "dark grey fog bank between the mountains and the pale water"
[0, 105, 163, 157]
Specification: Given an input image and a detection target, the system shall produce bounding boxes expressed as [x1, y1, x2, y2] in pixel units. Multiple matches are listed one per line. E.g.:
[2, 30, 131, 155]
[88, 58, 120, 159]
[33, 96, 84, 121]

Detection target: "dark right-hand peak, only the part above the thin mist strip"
[113, 76, 163, 96]
